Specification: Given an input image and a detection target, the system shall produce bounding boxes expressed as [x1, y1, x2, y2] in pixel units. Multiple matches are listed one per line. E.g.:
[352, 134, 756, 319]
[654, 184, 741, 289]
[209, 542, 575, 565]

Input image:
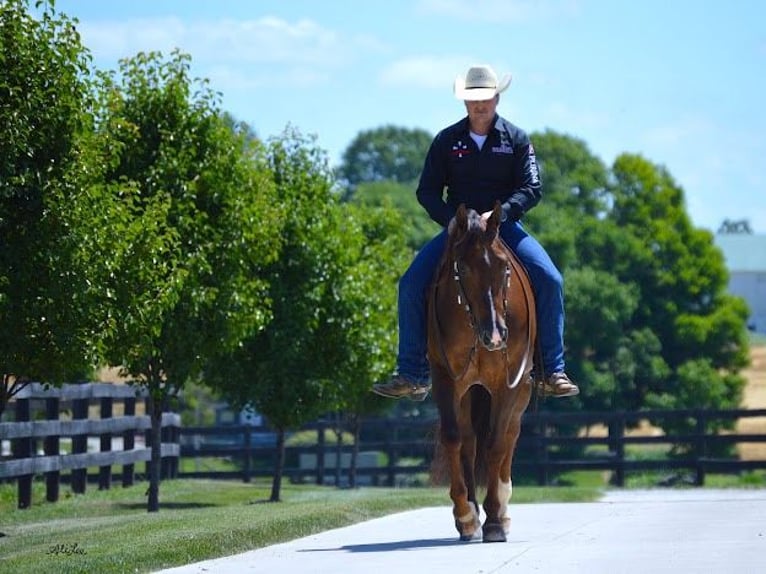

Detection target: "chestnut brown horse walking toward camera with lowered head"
[428, 203, 537, 542]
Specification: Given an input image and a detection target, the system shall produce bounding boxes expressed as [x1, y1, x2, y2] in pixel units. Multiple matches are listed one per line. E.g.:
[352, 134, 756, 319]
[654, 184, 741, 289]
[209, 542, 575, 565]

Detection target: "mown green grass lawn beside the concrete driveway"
[0, 480, 601, 574]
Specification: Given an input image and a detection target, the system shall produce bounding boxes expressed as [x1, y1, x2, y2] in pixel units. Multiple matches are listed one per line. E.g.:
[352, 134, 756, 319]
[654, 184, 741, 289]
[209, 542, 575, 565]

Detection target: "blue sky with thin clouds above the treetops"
[56, 0, 766, 233]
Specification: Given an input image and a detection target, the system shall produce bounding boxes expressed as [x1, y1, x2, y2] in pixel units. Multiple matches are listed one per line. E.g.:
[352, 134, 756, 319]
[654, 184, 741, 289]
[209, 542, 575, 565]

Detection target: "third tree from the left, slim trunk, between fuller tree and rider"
[205, 128, 346, 502]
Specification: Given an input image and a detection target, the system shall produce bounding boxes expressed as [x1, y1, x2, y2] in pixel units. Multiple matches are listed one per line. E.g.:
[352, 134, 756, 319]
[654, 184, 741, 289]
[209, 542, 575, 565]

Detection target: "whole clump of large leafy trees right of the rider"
[525, 136, 747, 432]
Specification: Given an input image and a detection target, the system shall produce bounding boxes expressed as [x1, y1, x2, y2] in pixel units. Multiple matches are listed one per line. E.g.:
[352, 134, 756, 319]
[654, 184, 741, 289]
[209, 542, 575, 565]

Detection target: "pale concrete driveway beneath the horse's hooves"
[156, 489, 766, 574]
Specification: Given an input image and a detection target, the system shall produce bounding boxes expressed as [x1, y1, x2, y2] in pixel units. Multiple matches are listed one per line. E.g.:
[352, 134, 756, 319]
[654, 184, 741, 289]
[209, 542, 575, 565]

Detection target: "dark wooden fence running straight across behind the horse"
[179, 409, 766, 486]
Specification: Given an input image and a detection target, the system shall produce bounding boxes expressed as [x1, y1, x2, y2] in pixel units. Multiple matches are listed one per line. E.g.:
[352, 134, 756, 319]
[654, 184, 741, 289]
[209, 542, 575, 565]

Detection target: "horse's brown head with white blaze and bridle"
[448, 202, 511, 351]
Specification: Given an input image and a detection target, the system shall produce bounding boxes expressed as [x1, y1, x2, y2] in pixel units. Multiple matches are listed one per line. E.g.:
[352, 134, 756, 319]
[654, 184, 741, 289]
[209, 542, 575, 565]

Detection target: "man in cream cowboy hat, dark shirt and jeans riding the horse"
[372, 65, 580, 401]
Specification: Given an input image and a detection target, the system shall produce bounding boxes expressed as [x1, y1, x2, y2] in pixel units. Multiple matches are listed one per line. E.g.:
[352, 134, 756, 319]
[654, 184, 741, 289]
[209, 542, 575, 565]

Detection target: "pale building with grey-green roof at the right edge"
[715, 233, 766, 334]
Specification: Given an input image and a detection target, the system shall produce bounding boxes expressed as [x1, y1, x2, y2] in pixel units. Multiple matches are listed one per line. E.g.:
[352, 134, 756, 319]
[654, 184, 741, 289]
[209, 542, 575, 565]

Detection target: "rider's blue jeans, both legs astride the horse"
[397, 221, 564, 382]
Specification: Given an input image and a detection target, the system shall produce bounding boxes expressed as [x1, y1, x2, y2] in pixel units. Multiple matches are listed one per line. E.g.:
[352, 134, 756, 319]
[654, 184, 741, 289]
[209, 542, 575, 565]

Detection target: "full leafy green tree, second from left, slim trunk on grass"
[91, 51, 282, 512]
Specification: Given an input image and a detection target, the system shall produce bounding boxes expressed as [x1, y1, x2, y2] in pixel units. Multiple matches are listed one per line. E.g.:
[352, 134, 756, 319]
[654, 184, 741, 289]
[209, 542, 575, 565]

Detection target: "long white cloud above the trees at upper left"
[80, 16, 388, 92]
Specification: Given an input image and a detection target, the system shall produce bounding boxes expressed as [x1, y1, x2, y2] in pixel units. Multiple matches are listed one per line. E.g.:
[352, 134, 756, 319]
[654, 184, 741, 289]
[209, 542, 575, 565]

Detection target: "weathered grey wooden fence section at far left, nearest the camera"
[0, 383, 181, 508]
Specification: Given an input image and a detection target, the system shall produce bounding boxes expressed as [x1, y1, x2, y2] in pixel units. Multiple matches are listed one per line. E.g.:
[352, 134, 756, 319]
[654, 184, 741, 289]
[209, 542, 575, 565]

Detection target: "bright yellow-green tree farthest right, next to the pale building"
[611, 154, 748, 370]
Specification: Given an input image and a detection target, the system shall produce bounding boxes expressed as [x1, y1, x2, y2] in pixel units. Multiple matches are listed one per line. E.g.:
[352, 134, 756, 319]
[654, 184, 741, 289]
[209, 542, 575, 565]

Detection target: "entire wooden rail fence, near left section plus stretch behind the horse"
[0, 396, 766, 508]
